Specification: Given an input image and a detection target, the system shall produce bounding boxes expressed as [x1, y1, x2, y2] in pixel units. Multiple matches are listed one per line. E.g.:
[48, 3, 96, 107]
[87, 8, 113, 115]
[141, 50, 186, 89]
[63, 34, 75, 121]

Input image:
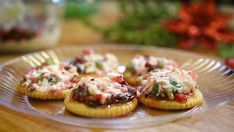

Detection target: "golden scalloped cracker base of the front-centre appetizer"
[64, 95, 137, 118]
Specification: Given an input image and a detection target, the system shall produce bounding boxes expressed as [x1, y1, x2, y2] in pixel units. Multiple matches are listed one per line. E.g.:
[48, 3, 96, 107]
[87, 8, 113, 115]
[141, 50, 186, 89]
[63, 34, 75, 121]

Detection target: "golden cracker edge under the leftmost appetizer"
[17, 85, 71, 100]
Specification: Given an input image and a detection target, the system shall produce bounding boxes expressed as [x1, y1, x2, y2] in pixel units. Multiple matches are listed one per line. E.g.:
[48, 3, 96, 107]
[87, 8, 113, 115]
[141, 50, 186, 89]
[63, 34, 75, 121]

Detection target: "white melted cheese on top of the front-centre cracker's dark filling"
[78, 73, 128, 104]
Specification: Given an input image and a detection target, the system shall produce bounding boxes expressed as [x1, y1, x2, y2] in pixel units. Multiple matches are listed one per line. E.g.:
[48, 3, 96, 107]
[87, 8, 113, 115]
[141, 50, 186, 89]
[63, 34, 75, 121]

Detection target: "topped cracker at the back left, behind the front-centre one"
[71, 49, 119, 75]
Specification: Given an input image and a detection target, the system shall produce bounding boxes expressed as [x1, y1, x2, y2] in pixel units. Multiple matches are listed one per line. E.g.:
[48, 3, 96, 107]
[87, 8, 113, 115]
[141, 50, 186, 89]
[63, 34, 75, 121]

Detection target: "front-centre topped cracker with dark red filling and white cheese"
[64, 73, 137, 118]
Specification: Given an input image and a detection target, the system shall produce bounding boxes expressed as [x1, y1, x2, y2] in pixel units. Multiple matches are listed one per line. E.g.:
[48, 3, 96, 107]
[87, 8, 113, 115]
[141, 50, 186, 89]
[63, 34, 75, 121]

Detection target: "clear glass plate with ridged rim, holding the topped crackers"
[0, 44, 234, 129]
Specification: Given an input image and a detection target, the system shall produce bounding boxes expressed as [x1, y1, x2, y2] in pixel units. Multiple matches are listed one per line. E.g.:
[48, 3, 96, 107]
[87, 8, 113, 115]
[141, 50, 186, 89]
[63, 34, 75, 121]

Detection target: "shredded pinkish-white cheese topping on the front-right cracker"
[141, 68, 197, 94]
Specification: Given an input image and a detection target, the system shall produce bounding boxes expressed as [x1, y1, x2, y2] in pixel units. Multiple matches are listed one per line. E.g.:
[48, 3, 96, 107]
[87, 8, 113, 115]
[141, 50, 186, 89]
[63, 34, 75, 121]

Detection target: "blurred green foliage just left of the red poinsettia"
[101, 0, 180, 47]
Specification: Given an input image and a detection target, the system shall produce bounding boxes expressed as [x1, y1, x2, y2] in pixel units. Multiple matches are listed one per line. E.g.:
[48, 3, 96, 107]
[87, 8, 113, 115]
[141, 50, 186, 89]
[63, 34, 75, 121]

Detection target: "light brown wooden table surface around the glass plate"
[0, 3, 234, 132]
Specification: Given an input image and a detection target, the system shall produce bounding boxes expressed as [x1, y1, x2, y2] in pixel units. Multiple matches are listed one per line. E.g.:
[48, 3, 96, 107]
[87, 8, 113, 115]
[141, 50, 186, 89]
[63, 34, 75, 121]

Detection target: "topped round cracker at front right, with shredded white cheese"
[139, 68, 203, 110]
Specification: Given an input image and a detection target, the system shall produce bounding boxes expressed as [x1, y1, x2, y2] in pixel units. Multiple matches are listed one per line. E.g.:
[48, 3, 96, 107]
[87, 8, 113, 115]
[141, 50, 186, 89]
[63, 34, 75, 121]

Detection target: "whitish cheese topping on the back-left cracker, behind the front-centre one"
[76, 53, 119, 74]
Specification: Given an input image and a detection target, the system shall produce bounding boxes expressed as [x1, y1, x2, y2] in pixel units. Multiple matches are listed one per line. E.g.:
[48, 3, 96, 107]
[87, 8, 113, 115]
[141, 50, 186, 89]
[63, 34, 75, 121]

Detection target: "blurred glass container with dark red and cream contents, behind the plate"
[0, 0, 64, 52]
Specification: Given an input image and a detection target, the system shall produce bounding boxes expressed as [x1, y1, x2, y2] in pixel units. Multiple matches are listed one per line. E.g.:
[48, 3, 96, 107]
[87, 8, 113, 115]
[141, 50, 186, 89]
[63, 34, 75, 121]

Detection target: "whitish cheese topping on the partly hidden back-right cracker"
[131, 55, 177, 74]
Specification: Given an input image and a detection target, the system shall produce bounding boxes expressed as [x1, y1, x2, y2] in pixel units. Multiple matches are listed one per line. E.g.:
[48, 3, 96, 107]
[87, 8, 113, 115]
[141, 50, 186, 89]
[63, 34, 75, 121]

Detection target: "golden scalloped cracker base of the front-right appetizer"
[139, 90, 203, 110]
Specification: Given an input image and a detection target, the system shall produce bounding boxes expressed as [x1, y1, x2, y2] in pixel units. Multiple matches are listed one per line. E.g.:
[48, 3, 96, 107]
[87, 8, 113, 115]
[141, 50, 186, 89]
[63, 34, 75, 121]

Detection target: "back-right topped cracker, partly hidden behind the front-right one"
[124, 55, 177, 86]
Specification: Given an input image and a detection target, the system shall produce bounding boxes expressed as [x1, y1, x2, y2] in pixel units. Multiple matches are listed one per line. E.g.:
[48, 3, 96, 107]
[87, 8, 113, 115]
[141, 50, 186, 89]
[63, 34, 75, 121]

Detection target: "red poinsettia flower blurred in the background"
[164, 0, 234, 49]
